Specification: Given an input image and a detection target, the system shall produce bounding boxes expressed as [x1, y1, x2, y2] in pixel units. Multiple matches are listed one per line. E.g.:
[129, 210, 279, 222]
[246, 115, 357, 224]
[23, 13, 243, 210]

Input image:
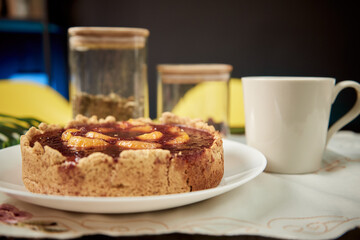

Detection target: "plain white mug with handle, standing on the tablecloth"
[242, 77, 360, 174]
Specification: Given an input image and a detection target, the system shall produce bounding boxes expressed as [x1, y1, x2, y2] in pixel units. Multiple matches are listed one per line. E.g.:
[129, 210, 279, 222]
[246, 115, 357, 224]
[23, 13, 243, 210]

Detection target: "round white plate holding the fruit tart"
[0, 139, 266, 213]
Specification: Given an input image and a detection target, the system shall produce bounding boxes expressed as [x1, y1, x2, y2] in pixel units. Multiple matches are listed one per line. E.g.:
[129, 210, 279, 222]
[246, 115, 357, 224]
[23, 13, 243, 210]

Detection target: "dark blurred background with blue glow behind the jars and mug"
[0, 0, 360, 132]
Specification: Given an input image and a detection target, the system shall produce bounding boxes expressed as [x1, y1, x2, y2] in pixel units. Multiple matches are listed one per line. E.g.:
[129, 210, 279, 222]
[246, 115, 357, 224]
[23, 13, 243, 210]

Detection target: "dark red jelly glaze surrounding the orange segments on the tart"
[30, 123, 214, 162]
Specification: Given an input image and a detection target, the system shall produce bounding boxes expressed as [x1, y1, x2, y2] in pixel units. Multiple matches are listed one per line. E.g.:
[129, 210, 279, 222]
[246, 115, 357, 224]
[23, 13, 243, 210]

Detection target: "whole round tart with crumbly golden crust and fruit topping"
[20, 113, 224, 197]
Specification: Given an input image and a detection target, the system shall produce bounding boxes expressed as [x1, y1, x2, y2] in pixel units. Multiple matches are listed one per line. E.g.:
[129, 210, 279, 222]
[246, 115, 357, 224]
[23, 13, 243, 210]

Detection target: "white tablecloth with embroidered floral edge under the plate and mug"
[0, 132, 360, 239]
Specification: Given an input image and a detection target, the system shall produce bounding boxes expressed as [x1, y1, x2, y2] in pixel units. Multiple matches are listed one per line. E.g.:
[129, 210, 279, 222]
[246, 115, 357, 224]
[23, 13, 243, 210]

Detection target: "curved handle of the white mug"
[326, 81, 360, 145]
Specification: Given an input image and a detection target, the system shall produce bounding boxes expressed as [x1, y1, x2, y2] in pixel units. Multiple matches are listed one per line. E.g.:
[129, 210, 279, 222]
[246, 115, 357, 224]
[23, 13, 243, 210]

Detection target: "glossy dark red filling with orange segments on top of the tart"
[30, 120, 214, 162]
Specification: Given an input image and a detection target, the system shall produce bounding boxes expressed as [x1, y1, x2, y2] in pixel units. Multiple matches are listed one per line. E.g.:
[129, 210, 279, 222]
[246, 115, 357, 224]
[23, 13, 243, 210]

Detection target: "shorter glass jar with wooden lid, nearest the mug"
[157, 64, 232, 136]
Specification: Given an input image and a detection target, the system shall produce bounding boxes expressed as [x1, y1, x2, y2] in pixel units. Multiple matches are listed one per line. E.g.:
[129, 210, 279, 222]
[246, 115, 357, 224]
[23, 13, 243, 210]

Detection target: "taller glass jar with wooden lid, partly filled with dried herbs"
[68, 27, 149, 120]
